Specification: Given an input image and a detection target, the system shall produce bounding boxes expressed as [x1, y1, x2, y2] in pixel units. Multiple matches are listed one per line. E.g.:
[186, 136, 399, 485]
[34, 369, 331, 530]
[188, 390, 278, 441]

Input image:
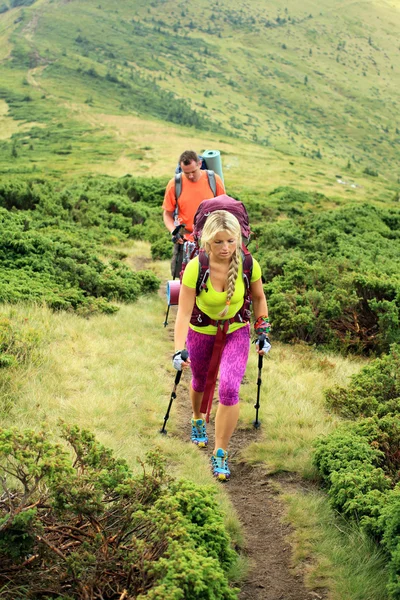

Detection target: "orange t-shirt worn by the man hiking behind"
[162, 171, 225, 231]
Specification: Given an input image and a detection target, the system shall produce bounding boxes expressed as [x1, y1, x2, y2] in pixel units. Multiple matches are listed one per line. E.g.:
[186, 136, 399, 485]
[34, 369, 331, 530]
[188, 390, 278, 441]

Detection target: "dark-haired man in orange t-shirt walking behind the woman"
[162, 150, 225, 278]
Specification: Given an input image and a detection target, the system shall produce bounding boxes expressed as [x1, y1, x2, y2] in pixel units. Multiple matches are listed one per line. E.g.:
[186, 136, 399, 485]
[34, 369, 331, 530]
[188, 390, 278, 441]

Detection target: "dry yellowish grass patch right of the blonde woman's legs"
[236, 342, 365, 478]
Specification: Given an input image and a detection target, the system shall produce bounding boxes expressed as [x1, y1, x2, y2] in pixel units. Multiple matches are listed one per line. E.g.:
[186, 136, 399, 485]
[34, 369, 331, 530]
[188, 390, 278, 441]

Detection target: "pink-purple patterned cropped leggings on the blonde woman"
[187, 324, 250, 406]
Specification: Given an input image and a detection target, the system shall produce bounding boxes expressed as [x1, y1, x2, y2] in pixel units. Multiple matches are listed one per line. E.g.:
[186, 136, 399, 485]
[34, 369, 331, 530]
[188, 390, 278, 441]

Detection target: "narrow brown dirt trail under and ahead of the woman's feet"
[170, 376, 327, 600]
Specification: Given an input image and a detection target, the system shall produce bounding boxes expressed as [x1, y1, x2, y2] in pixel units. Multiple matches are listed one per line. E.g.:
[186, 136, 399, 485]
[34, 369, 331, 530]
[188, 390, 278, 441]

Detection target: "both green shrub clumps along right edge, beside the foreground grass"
[314, 345, 400, 599]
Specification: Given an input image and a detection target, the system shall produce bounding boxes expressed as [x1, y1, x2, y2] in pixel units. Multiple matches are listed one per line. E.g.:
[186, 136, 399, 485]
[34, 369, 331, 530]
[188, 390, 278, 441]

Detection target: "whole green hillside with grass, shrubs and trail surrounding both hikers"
[0, 0, 400, 600]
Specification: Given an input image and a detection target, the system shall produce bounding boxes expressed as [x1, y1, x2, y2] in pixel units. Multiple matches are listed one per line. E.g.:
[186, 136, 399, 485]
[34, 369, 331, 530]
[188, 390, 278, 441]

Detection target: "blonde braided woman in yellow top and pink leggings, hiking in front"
[173, 210, 271, 480]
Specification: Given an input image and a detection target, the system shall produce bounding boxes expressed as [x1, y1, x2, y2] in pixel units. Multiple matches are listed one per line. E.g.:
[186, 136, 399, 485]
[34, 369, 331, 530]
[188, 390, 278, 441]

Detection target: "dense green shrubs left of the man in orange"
[0, 178, 159, 314]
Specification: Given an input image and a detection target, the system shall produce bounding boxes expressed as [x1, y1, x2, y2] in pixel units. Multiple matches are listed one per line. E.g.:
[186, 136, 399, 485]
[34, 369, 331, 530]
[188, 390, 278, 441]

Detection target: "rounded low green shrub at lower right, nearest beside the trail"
[313, 413, 400, 599]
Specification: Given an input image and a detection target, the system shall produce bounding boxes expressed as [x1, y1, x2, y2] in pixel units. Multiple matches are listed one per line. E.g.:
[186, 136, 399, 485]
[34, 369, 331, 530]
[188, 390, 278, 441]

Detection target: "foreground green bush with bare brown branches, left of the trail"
[0, 426, 237, 600]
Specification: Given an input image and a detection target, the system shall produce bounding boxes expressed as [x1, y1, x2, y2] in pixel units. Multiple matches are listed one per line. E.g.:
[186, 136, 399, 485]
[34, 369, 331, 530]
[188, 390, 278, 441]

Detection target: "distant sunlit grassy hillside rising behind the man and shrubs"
[0, 0, 400, 201]
